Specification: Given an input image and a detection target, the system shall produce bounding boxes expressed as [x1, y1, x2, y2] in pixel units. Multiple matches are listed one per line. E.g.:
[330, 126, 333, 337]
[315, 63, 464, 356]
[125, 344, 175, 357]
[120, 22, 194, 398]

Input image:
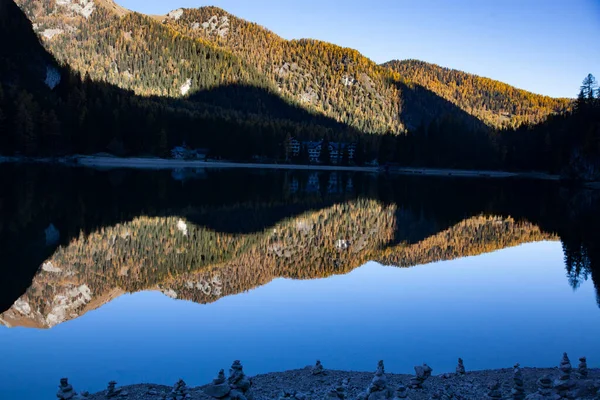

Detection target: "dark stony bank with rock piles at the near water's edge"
[74, 360, 600, 400]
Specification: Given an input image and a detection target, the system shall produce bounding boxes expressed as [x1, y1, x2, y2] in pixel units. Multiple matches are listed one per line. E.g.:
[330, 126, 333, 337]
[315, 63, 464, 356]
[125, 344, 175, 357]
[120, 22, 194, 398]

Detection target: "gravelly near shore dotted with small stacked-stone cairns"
[72, 359, 600, 400]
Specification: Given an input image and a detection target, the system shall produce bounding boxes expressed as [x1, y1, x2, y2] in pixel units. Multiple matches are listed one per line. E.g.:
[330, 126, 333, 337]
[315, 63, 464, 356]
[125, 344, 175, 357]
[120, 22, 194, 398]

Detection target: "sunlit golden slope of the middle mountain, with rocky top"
[164, 7, 402, 133]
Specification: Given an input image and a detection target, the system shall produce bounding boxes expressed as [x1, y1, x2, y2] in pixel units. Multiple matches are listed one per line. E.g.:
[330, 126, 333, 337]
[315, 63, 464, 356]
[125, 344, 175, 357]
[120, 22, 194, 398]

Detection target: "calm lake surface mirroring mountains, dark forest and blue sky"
[0, 166, 600, 399]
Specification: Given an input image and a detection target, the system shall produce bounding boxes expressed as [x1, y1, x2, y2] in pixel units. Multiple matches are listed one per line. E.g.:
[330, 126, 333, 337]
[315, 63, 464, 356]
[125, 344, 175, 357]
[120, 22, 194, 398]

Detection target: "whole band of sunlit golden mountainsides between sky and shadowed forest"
[11, 0, 567, 133]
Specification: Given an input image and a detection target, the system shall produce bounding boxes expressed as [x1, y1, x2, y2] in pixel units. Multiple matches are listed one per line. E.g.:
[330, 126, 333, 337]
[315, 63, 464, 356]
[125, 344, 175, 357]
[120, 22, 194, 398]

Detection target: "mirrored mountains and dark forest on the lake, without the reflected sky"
[0, 166, 600, 328]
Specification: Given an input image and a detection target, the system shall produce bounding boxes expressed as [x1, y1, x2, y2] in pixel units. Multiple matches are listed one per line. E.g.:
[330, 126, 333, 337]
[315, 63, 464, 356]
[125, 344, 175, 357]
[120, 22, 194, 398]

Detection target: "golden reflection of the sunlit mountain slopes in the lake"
[0, 200, 556, 328]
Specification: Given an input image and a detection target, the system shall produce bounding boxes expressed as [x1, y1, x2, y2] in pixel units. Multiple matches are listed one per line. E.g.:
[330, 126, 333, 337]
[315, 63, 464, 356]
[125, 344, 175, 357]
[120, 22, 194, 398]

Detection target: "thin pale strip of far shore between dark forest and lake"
[0, 155, 568, 181]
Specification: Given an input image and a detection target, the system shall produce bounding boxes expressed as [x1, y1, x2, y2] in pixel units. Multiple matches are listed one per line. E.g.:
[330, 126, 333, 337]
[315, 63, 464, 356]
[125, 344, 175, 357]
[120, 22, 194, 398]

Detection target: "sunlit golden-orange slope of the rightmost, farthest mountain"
[383, 60, 572, 127]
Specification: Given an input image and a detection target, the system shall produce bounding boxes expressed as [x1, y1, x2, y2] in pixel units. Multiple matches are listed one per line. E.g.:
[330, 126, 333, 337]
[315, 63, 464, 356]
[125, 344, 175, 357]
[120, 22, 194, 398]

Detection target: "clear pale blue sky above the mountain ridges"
[116, 0, 600, 97]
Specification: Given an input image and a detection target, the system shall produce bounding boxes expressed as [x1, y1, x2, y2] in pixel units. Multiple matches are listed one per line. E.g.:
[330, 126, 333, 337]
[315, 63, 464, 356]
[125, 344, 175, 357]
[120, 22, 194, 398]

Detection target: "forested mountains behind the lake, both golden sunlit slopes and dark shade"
[0, 0, 600, 181]
